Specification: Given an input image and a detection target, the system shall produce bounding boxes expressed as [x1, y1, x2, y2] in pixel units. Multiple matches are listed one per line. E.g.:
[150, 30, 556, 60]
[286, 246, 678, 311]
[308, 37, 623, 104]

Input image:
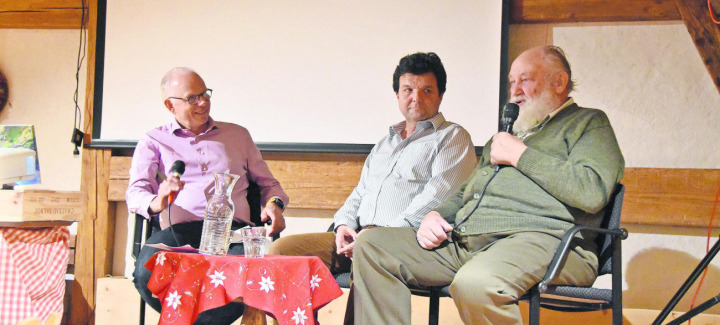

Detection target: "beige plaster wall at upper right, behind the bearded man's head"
[509, 22, 720, 168]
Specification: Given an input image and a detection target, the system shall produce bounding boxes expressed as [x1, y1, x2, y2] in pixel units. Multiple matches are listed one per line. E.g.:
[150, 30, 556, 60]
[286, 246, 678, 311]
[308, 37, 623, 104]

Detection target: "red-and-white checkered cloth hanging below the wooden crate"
[0, 227, 70, 325]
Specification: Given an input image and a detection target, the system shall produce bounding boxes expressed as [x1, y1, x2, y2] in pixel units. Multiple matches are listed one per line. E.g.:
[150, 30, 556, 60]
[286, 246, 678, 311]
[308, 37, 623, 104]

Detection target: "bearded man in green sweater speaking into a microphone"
[353, 46, 625, 324]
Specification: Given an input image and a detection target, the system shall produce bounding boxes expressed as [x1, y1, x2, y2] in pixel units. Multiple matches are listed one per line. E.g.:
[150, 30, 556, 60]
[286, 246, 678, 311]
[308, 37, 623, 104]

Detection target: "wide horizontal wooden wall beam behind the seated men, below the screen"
[108, 154, 720, 227]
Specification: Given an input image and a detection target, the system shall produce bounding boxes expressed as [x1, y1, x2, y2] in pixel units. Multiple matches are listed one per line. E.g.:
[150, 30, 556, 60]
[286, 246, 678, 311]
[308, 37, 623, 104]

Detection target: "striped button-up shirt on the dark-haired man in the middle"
[335, 113, 477, 229]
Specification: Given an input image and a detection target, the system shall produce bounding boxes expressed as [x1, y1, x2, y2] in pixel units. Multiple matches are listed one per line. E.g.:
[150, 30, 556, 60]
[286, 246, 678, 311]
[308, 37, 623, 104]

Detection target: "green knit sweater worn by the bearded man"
[436, 104, 625, 249]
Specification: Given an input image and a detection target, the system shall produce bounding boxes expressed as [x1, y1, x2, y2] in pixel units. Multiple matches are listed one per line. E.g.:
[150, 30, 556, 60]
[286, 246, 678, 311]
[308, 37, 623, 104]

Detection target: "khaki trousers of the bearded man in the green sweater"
[353, 228, 597, 325]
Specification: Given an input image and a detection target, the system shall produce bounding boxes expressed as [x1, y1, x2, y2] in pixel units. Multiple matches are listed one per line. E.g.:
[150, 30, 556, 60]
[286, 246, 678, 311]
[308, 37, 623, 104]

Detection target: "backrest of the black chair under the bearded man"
[596, 184, 625, 275]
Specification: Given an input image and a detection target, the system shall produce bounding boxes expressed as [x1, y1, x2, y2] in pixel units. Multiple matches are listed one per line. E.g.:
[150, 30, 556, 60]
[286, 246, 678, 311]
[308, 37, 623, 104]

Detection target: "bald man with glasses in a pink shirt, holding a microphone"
[126, 68, 288, 324]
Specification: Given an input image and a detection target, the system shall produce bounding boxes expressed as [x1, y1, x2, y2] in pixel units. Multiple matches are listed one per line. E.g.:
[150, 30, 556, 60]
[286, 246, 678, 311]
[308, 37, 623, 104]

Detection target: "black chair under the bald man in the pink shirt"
[132, 182, 268, 325]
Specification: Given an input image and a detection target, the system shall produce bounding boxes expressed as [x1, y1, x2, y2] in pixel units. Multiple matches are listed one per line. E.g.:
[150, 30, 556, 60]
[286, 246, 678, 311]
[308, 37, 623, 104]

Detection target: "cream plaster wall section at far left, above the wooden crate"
[0, 29, 86, 191]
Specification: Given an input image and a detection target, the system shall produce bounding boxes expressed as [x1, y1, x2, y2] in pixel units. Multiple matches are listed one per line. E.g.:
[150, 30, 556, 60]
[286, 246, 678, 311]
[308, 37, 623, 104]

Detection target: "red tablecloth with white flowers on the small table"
[145, 251, 342, 324]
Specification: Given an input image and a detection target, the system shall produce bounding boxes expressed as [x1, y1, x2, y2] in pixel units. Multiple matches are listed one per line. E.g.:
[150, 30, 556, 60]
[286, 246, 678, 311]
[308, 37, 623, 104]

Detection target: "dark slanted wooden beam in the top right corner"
[675, 0, 720, 92]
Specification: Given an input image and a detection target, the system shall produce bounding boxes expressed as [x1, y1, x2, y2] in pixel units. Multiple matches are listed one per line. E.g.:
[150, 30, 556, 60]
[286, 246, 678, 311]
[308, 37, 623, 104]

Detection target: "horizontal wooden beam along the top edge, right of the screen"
[510, 0, 680, 24]
